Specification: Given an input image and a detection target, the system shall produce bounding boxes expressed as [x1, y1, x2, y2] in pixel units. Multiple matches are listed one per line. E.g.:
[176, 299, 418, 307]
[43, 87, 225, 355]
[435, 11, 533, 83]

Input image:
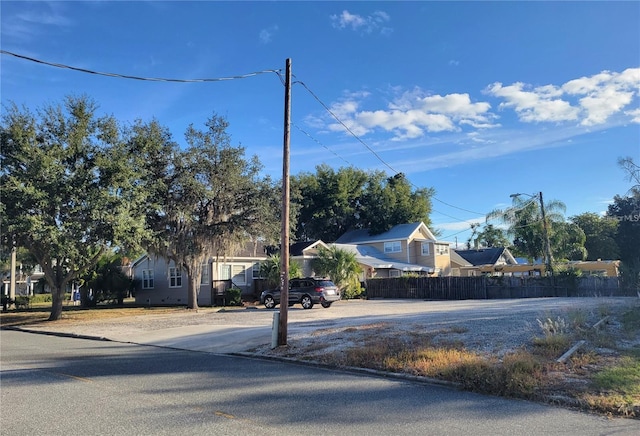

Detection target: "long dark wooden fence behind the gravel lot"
[365, 276, 638, 300]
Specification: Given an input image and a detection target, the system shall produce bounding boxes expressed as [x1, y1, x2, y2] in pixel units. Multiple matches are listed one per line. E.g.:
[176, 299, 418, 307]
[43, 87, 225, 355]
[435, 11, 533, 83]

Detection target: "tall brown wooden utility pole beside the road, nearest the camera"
[278, 58, 291, 346]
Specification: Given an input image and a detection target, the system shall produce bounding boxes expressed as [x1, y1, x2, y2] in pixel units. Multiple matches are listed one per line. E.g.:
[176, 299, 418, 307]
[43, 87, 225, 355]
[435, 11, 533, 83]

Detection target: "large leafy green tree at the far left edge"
[0, 96, 143, 320]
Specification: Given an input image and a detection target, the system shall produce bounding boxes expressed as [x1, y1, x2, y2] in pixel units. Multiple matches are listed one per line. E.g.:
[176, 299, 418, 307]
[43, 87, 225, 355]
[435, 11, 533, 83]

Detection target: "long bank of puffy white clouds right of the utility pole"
[314, 68, 640, 143]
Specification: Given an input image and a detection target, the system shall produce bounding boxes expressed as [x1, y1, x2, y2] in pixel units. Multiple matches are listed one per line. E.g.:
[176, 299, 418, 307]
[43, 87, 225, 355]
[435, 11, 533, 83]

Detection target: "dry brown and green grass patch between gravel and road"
[298, 307, 640, 418]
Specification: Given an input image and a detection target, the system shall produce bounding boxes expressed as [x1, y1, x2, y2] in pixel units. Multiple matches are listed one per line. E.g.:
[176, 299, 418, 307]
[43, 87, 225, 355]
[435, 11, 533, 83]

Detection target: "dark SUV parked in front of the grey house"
[260, 277, 340, 309]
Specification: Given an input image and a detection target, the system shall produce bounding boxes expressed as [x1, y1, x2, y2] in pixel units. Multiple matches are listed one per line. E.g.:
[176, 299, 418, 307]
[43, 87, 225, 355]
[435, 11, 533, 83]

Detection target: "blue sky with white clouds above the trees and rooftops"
[0, 0, 640, 244]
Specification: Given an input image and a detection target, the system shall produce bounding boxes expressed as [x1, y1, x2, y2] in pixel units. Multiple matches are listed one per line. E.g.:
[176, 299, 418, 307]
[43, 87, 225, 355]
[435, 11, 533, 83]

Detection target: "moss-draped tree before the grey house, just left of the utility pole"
[136, 114, 278, 309]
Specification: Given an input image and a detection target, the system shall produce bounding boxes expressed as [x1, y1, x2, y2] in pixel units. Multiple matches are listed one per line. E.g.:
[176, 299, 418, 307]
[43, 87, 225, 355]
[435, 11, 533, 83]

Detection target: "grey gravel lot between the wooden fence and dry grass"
[252, 298, 640, 359]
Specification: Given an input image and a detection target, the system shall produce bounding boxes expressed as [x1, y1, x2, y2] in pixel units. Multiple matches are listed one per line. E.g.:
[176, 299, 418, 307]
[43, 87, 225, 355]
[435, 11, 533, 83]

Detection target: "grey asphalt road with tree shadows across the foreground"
[0, 330, 640, 436]
